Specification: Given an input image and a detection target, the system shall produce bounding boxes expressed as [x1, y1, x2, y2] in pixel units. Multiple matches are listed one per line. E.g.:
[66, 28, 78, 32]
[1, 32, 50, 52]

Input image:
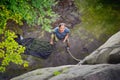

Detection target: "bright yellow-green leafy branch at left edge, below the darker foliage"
[0, 31, 28, 71]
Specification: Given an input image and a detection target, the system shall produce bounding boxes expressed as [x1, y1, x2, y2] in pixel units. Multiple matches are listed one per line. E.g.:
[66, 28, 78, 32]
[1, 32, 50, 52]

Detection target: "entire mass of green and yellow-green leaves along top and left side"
[0, 0, 57, 71]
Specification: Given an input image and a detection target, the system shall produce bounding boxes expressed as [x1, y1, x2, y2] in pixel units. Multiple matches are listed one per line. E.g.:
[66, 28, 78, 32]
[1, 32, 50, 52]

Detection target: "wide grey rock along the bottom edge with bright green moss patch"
[11, 64, 120, 80]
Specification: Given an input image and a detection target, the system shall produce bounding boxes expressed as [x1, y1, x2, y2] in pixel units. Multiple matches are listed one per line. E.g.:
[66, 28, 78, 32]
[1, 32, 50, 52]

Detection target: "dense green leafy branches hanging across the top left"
[0, 0, 57, 32]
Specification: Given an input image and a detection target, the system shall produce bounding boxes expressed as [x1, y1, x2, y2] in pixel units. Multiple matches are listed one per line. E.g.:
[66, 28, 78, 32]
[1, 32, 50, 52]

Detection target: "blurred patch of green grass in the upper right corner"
[75, 0, 120, 37]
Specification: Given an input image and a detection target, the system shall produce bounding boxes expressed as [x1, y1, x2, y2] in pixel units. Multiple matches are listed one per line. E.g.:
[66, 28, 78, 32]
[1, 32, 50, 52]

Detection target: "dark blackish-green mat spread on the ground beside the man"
[22, 38, 53, 59]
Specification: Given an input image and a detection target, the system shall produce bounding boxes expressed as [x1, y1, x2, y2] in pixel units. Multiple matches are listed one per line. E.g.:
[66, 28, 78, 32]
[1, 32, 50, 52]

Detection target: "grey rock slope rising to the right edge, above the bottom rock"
[80, 31, 120, 64]
